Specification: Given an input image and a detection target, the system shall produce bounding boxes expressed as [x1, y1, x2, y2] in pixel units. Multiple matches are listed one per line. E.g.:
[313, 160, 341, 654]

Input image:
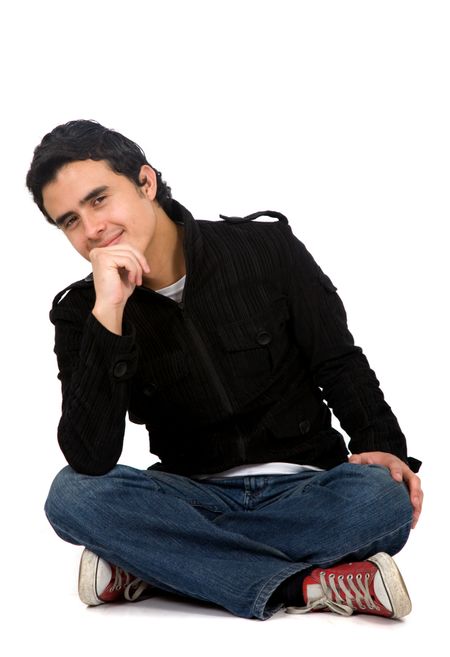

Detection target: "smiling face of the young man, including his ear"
[42, 160, 157, 260]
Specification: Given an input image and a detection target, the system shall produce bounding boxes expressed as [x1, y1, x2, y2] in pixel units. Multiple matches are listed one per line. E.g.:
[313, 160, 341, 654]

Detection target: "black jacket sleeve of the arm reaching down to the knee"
[282, 226, 420, 471]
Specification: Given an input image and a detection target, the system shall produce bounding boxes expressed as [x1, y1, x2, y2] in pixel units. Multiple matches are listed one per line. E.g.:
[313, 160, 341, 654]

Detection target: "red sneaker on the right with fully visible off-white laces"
[286, 552, 411, 618]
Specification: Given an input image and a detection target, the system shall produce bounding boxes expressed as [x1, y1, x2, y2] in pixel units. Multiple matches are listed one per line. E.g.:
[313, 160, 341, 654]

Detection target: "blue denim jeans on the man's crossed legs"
[45, 463, 412, 619]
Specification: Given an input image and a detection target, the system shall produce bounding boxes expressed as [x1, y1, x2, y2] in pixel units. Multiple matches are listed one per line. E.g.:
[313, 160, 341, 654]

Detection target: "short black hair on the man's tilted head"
[26, 120, 172, 225]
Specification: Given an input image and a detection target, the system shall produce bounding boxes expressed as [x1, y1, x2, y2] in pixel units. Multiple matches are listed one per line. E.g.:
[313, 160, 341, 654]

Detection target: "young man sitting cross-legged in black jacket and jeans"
[27, 121, 422, 619]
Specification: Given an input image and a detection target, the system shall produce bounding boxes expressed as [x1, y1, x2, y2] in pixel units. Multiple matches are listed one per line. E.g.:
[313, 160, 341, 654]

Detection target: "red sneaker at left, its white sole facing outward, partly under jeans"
[78, 548, 151, 606]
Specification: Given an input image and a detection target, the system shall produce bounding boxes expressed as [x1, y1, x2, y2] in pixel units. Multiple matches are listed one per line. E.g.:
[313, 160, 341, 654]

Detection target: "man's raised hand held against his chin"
[89, 244, 150, 335]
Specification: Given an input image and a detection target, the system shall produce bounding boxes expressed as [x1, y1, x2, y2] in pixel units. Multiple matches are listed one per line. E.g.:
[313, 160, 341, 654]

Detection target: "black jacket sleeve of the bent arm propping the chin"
[50, 292, 137, 475]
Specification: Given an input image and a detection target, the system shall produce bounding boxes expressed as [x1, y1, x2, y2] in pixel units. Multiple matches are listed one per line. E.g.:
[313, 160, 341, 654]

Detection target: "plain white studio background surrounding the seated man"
[0, 0, 450, 655]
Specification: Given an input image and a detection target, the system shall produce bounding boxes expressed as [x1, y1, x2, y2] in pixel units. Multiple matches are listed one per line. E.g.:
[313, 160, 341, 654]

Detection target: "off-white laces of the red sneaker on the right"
[285, 571, 380, 616]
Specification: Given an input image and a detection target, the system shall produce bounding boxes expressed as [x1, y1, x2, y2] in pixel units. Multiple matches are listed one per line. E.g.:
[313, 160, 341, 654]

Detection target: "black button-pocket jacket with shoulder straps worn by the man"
[50, 201, 419, 475]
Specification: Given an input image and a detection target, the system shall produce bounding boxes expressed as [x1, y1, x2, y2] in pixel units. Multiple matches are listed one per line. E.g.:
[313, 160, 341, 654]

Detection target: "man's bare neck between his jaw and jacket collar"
[144, 206, 186, 290]
